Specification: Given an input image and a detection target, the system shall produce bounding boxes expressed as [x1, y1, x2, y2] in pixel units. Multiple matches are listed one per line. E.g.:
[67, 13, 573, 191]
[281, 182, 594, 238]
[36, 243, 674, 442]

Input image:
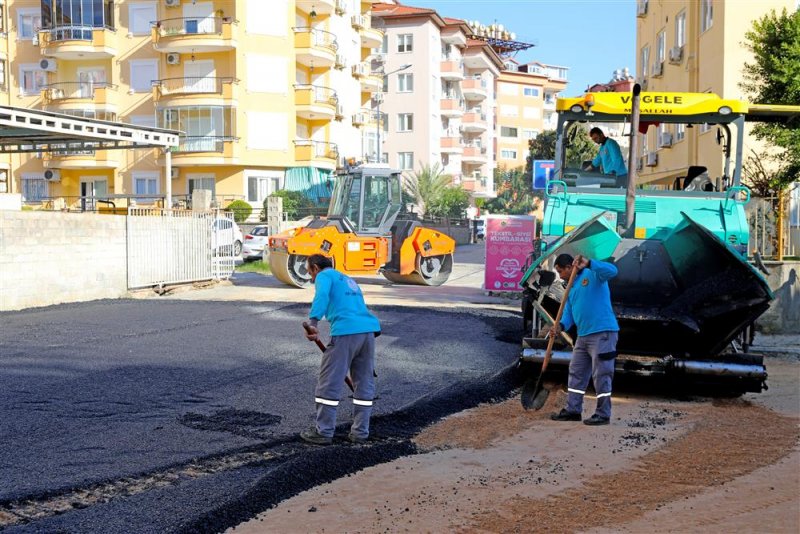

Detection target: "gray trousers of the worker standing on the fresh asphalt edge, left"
[314, 332, 375, 439]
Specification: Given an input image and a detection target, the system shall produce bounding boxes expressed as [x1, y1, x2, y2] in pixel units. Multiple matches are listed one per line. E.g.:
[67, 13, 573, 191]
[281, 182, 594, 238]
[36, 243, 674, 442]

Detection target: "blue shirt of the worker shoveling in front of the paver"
[561, 260, 619, 336]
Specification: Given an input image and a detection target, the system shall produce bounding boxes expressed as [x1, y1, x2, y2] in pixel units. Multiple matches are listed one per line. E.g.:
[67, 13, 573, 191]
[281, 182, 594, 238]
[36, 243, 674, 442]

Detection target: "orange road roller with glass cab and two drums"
[269, 165, 455, 287]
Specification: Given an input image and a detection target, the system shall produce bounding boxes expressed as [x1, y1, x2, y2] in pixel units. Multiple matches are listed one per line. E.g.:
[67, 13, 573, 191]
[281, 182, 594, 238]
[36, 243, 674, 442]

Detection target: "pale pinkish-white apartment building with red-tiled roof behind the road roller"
[372, 4, 503, 197]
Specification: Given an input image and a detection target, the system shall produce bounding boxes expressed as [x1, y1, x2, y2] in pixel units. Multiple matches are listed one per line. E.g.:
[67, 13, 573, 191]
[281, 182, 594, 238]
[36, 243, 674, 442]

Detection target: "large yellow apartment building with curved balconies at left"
[0, 0, 383, 214]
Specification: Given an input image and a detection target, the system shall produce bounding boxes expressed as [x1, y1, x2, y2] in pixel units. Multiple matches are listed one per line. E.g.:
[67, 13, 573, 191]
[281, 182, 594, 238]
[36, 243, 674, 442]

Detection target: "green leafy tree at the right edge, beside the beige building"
[740, 9, 800, 191]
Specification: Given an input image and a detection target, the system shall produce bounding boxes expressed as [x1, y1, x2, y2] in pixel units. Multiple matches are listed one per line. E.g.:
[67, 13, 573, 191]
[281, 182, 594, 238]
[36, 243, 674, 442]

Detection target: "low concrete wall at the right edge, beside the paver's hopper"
[758, 261, 800, 334]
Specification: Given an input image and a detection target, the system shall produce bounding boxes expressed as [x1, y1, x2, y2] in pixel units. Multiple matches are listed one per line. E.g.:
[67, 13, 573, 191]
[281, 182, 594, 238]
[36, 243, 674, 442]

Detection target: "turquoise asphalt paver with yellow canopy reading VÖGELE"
[521, 90, 800, 393]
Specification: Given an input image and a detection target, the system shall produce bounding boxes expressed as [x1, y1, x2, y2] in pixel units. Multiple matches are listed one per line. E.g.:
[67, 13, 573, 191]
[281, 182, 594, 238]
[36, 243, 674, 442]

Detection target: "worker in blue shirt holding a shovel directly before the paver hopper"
[550, 254, 619, 425]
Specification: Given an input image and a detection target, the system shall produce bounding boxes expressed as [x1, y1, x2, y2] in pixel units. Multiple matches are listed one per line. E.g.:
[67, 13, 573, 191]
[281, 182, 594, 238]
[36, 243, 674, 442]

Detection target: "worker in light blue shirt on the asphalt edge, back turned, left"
[300, 254, 381, 445]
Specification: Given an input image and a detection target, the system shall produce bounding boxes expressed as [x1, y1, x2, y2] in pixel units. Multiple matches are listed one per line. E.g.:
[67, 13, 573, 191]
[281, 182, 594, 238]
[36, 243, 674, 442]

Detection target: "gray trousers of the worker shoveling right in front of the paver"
[567, 332, 618, 419]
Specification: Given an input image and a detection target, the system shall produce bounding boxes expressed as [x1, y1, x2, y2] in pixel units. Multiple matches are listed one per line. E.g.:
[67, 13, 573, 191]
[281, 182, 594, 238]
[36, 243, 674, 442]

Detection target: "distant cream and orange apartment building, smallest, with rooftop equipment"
[496, 58, 568, 170]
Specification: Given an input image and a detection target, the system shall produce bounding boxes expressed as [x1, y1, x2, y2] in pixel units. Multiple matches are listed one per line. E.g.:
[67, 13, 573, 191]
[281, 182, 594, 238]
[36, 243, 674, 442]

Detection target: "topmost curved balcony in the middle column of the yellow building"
[151, 17, 238, 54]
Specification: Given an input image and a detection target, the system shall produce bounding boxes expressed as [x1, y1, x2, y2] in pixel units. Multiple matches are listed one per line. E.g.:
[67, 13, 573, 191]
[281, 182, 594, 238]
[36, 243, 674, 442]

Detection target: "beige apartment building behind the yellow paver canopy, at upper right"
[636, 0, 797, 187]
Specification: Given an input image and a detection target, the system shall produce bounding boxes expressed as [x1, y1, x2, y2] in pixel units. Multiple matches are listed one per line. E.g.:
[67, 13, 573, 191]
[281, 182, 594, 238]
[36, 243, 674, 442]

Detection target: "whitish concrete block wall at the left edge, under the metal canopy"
[0, 210, 127, 311]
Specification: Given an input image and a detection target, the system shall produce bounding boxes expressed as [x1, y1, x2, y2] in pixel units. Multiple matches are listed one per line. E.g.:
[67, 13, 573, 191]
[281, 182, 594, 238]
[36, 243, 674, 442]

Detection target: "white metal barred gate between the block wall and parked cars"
[127, 208, 235, 289]
